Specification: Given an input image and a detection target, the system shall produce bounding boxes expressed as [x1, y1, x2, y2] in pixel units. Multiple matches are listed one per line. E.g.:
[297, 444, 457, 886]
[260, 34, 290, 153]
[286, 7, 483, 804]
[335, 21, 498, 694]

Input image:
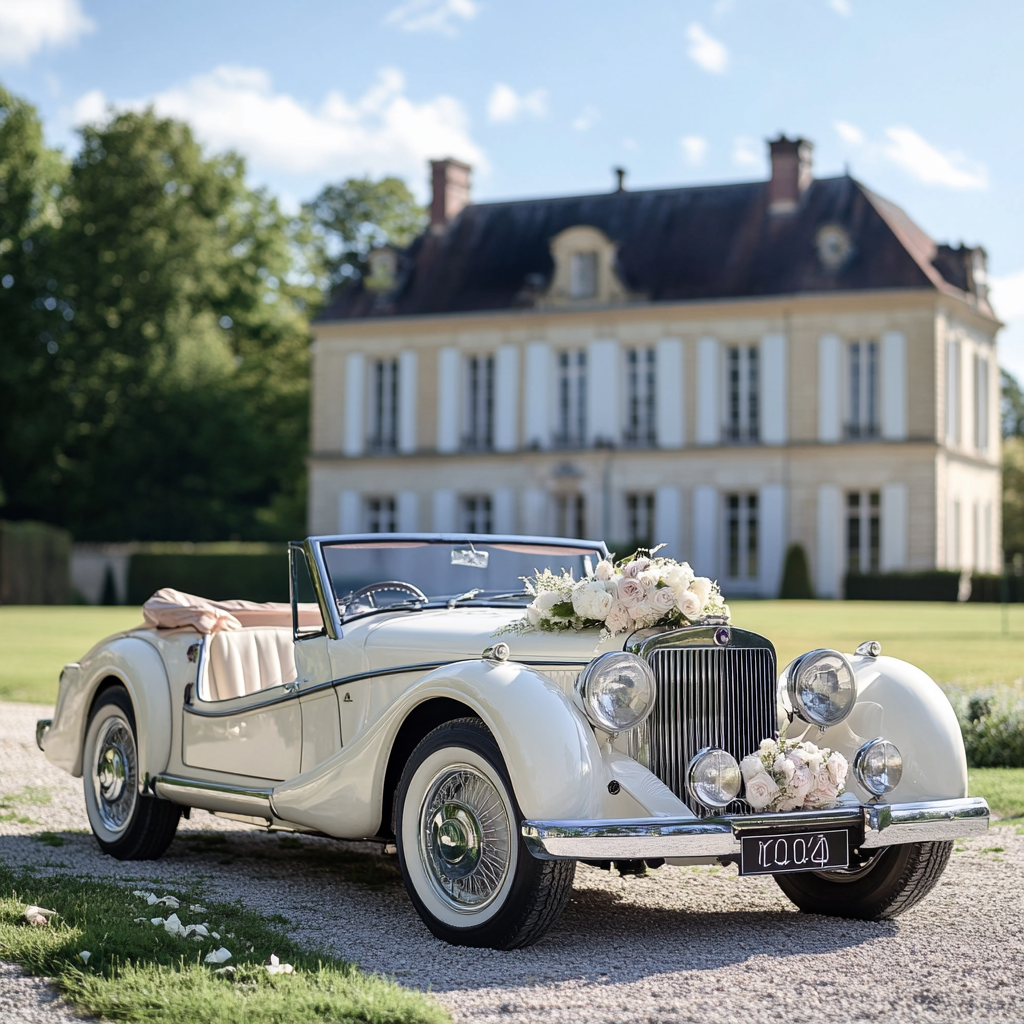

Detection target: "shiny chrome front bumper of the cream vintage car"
[522, 797, 988, 860]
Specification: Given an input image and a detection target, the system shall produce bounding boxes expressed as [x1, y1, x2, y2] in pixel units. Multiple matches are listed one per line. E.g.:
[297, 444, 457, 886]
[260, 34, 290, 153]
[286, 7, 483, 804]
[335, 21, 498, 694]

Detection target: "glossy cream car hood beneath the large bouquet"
[362, 608, 626, 670]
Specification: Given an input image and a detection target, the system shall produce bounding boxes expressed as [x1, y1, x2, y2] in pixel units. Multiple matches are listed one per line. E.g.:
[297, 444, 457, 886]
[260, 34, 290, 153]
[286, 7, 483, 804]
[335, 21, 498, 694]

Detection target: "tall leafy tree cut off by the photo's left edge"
[0, 86, 66, 518]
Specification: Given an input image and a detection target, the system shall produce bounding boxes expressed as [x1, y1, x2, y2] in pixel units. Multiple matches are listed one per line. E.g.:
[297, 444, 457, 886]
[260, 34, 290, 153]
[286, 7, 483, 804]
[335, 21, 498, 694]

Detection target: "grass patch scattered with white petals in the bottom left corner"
[0, 865, 449, 1024]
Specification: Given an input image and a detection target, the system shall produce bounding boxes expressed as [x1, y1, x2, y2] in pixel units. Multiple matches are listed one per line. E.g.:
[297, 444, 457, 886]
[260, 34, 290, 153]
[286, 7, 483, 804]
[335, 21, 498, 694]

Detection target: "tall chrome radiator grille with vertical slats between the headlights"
[629, 647, 778, 816]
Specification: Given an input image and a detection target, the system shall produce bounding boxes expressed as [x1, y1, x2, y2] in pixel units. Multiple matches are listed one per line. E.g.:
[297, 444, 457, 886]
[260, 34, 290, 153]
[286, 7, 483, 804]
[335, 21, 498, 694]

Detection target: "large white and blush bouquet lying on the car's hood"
[499, 548, 729, 636]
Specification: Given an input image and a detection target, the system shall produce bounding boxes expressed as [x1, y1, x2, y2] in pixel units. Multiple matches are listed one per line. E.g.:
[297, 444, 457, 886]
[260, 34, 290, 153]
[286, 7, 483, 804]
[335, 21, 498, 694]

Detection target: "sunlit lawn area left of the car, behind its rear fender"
[0, 605, 142, 705]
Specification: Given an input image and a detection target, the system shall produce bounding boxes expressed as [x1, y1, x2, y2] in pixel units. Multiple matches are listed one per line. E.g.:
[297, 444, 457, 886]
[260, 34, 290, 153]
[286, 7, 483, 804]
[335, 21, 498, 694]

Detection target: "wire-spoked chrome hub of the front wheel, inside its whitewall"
[420, 765, 512, 911]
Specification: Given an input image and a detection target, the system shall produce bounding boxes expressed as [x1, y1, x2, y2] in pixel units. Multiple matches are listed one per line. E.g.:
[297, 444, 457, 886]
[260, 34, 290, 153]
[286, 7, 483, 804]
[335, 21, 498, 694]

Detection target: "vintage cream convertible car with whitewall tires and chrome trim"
[38, 535, 988, 948]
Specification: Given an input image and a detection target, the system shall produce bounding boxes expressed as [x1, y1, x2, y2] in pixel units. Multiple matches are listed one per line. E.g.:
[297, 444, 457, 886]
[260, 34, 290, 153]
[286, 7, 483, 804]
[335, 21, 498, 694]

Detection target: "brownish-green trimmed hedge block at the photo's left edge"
[0, 520, 71, 604]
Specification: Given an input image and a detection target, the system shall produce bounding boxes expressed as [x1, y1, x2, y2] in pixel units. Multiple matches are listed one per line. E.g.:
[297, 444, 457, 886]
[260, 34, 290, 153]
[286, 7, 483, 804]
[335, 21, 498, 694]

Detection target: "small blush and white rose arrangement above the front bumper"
[739, 738, 850, 811]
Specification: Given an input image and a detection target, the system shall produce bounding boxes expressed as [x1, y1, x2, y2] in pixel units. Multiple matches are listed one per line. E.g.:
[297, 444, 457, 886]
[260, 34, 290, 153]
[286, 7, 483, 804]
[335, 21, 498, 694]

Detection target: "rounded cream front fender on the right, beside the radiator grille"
[790, 656, 967, 803]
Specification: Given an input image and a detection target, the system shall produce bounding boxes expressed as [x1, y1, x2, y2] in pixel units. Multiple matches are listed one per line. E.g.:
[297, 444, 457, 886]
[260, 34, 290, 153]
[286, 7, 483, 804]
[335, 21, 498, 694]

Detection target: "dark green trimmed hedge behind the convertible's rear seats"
[127, 545, 288, 604]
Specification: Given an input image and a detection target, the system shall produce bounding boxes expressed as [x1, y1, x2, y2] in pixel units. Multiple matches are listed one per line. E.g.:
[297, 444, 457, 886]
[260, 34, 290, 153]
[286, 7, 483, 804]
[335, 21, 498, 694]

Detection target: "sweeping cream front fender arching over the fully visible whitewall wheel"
[273, 662, 608, 837]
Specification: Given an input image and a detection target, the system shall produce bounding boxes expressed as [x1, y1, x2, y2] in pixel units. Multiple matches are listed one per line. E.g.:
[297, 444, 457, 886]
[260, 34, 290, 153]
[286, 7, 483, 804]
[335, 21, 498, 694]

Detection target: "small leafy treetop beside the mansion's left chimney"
[306, 177, 427, 287]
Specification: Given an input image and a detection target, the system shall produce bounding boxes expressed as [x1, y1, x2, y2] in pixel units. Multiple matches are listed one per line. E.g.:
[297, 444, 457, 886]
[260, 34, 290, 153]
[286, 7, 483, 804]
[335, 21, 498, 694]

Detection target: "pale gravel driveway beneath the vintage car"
[0, 703, 1024, 1024]
